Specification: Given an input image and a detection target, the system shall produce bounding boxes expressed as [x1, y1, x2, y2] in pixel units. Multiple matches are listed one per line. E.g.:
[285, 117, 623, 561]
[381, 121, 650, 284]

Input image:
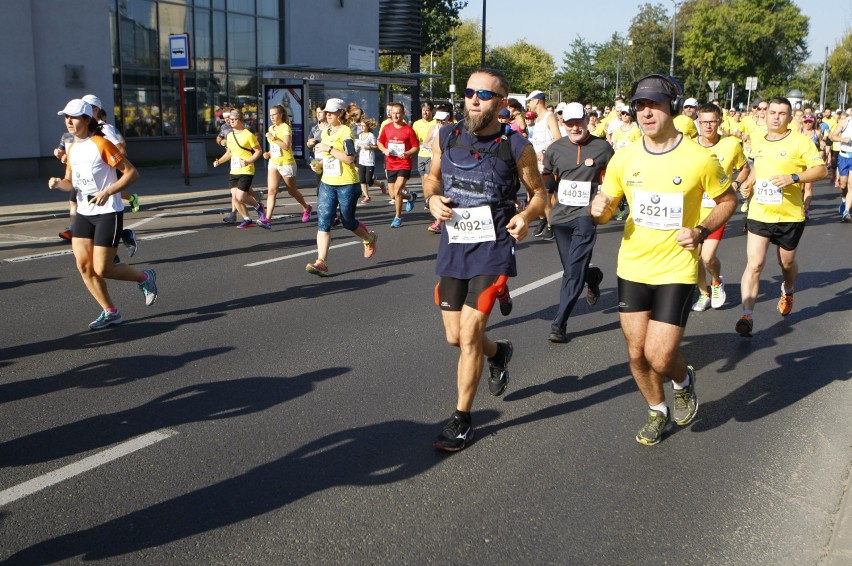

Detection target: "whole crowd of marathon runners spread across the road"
[48, 69, 840, 452]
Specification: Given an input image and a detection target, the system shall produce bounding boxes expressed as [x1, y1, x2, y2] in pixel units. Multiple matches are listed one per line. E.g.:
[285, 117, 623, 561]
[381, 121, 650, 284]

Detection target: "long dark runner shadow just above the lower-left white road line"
[0, 367, 350, 466]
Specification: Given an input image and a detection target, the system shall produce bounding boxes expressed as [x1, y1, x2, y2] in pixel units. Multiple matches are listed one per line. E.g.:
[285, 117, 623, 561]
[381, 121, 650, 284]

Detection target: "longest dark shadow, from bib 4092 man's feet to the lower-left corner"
[3, 410, 497, 564]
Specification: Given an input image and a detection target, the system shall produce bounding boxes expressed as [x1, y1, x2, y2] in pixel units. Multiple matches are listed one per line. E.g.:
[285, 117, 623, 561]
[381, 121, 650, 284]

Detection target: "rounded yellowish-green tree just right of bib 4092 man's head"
[485, 39, 556, 92]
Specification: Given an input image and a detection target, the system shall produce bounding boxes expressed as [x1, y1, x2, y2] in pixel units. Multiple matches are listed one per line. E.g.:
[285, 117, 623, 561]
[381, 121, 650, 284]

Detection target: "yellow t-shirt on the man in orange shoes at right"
[748, 130, 825, 224]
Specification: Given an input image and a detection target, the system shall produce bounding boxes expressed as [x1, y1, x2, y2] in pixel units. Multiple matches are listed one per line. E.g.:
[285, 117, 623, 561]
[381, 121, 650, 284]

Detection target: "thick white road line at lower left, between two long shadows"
[0, 429, 177, 507]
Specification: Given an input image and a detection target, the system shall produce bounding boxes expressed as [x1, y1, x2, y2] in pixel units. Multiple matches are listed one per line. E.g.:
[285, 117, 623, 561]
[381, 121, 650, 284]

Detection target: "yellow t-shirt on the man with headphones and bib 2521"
[601, 139, 730, 285]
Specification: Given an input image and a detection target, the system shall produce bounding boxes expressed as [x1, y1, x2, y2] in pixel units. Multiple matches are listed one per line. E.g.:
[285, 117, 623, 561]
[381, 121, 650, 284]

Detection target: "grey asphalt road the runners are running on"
[0, 182, 852, 565]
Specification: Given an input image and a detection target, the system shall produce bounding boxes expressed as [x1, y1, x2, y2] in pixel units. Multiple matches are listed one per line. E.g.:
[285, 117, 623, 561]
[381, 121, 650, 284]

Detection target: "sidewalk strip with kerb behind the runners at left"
[0, 162, 326, 226]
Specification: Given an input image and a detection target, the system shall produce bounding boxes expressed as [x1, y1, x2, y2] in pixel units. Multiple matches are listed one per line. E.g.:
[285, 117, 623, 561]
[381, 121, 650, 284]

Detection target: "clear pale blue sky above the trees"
[460, 0, 852, 67]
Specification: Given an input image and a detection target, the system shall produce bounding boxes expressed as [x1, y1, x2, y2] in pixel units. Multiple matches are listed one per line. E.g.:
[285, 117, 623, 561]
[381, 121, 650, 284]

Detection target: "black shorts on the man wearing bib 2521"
[618, 277, 695, 327]
